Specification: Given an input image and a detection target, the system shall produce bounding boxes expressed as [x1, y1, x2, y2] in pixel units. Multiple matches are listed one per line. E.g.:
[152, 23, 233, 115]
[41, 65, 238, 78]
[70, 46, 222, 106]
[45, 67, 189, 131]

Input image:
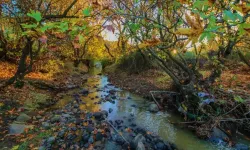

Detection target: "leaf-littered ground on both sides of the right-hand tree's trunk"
[106, 66, 250, 96]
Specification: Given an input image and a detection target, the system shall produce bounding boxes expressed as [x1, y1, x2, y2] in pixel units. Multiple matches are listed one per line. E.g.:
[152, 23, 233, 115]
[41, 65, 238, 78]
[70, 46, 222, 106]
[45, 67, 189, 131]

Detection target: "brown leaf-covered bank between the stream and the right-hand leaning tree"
[105, 69, 172, 97]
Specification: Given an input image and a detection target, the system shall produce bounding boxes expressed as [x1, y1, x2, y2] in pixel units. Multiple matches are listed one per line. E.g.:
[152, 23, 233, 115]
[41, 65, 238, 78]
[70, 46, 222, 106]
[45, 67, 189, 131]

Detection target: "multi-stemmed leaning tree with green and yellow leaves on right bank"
[116, 0, 249, 117]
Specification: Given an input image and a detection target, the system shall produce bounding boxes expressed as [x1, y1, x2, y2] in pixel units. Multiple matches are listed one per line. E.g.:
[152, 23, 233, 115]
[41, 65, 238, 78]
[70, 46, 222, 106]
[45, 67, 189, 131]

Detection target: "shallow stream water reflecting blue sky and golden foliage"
[51, 64, 249, 150]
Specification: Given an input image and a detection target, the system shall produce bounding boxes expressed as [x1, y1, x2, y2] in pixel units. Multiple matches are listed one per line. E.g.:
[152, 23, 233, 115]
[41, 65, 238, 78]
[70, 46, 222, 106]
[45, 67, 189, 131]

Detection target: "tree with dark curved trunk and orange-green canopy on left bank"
[1, 0, 112, 85]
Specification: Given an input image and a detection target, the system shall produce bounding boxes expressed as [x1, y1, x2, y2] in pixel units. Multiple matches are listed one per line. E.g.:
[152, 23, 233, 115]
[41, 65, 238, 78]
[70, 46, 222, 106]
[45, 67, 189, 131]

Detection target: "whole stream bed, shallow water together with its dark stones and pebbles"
[0, 61, 249, 150]
